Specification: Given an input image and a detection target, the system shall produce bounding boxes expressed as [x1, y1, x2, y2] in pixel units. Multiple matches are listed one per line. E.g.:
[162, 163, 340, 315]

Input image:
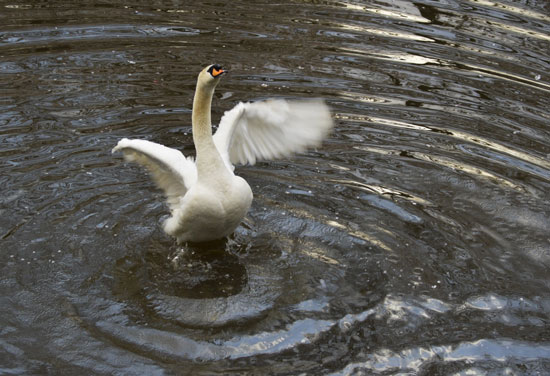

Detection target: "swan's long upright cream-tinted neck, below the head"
[192, 82, 227, 180]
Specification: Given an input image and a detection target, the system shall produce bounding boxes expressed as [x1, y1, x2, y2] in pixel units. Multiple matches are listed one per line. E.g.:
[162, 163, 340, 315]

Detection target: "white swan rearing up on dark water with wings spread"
[113, 64, 333, 243]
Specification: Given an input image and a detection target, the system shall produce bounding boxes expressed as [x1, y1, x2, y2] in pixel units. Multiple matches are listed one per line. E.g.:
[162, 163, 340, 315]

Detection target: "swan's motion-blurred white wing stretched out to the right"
[214, 99, 333, 165]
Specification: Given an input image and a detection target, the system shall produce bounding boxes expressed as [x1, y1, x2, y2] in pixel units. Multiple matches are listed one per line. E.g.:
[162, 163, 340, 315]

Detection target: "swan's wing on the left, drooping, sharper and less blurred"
[113, 138, 197, 209]
